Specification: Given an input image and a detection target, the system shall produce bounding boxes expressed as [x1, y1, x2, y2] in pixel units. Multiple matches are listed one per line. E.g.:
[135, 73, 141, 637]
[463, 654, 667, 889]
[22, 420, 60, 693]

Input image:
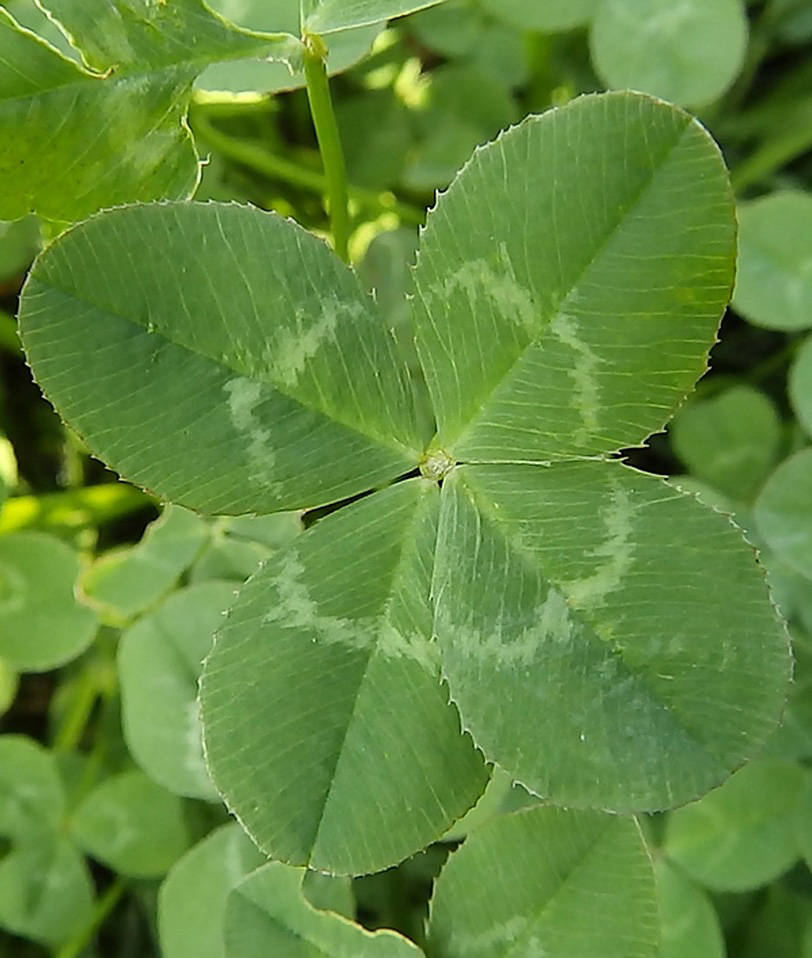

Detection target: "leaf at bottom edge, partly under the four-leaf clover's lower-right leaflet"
[429, 808, 658, 958]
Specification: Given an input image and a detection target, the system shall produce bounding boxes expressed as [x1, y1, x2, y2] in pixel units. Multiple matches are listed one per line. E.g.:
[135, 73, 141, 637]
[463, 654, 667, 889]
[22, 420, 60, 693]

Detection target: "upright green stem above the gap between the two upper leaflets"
[304, 35, 350, 263]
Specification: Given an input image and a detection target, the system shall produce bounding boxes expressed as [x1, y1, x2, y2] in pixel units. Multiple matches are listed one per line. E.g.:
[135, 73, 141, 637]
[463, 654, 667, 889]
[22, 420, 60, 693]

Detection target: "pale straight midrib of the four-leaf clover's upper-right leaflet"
[432, 110, 693, 452]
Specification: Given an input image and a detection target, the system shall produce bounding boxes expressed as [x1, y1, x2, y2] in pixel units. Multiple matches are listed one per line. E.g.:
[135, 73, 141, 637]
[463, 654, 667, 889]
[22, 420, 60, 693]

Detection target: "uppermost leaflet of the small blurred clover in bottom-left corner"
[0, 735, 65, 839]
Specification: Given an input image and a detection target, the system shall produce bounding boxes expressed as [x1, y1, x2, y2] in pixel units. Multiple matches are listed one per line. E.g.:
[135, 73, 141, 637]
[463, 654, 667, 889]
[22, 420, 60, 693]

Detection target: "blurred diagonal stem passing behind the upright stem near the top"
[192, 107, 425, 226]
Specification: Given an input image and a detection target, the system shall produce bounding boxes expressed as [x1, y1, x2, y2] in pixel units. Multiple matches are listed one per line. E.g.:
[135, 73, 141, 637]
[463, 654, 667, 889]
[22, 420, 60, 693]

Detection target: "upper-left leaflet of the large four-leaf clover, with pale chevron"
[20, 204, 423, 514]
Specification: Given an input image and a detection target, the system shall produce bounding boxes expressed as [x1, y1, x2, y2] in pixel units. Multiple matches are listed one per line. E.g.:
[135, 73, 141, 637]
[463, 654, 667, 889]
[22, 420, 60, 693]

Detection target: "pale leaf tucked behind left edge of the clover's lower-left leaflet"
[118, 582, 234, 801]
